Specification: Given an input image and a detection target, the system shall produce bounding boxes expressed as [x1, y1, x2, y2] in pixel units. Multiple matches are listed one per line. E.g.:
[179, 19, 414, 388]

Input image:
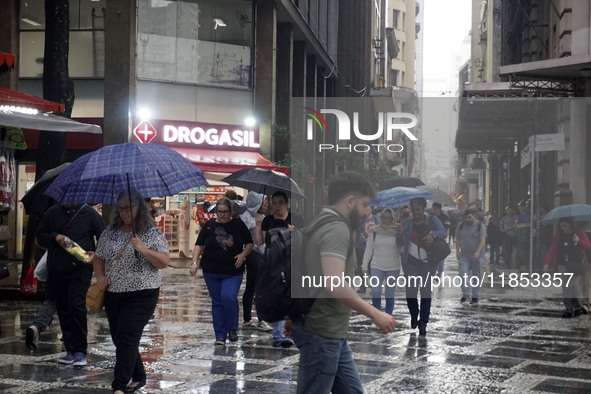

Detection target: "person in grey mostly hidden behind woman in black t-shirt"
[240, 191, 273, 331]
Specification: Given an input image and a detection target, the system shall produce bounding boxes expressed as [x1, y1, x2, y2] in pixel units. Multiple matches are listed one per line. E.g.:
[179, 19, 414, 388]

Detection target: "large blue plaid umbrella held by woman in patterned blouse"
[45, 142, 207, 205]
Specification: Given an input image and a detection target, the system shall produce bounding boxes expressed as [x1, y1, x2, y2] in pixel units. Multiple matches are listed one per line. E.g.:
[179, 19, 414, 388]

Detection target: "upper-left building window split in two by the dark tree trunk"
[18, 0, 106, 78]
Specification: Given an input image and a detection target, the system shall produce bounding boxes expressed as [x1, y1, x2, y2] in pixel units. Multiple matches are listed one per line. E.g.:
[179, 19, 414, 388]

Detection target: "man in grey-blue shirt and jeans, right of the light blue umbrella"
[456, 209, 486, 305]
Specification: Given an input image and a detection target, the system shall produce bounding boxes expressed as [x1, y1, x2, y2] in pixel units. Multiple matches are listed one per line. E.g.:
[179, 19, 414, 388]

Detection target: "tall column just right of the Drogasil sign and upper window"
[254, 1, 277, 160]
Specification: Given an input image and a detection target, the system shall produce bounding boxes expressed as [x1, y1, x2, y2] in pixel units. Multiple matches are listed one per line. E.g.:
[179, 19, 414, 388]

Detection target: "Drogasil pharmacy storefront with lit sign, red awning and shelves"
[131, 119, 288, 257]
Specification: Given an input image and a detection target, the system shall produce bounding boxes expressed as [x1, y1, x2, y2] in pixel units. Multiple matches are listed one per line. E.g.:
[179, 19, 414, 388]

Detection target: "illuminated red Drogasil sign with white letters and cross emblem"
[134, 120, 260, 152]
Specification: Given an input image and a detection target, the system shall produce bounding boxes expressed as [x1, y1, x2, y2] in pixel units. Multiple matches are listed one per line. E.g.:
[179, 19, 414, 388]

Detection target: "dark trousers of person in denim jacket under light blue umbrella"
[402, 256, 437, 327]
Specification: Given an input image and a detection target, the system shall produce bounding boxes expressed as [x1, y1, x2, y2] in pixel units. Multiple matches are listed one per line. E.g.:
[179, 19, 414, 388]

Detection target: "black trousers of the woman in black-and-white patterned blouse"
[105, 289, 160, 391]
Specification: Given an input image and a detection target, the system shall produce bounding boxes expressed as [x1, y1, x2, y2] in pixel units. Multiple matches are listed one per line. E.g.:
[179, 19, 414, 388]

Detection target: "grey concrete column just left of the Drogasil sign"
[103, 0, 137, 145]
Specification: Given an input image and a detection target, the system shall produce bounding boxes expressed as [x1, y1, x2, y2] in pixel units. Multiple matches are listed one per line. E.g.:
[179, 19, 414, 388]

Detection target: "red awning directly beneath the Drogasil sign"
[172, 147, 289, 175]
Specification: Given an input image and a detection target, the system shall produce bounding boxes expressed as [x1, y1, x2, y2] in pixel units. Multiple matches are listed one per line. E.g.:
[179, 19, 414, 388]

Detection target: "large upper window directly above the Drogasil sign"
[136, 0, 253, 88]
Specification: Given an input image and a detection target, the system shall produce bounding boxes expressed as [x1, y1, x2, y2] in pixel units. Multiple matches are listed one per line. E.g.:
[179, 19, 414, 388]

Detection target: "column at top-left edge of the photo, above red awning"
[0, 0, 19, 90]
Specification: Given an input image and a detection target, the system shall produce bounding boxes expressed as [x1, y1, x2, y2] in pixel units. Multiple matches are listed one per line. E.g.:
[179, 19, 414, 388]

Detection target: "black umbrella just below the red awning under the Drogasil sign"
[222, 168, 305, 197]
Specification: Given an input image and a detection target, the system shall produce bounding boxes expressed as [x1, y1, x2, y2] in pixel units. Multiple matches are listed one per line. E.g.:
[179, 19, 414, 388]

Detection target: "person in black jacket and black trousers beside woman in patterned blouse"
[35, 204, 105, 366]
